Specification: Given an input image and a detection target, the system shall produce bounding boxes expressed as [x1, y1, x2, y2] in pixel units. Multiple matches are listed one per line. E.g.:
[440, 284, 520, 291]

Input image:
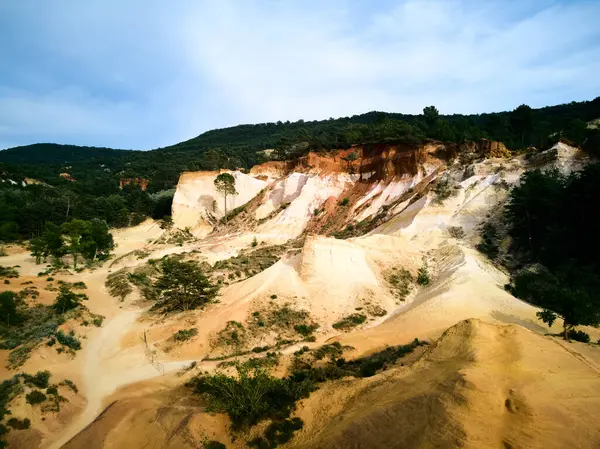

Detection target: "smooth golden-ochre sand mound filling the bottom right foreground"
[290, 320, 600, 449]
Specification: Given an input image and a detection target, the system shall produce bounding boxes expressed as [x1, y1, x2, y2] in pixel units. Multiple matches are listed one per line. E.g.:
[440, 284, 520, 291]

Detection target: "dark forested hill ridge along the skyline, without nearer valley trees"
[0, 97, 600, 191]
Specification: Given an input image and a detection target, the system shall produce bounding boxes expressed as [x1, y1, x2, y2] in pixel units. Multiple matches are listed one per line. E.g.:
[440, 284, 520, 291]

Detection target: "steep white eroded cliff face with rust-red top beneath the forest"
[173, 139, 508, 241]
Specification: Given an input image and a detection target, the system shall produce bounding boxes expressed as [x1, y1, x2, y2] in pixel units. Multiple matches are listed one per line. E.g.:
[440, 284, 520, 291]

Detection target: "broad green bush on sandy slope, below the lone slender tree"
[153, 258, 218, 313]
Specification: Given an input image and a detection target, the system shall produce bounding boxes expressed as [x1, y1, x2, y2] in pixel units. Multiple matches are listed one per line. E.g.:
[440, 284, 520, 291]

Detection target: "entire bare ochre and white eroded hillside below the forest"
[0, 134, 600, 449]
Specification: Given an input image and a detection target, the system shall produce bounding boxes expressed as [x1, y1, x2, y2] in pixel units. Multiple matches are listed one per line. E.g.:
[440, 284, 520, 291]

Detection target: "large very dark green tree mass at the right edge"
[506, 164, 600, 339]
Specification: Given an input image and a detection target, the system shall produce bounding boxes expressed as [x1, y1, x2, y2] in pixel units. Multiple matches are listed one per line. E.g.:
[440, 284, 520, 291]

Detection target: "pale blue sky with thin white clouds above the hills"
[0, 0, 600, 150]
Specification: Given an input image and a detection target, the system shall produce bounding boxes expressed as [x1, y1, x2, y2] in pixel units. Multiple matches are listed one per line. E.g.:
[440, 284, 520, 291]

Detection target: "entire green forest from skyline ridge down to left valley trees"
[0, 97, 600, 242]
